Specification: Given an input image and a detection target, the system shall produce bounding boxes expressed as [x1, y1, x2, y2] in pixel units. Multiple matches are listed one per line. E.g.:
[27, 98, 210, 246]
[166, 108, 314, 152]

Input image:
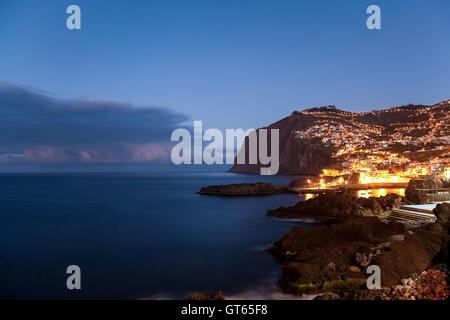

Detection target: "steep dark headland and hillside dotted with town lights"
[230, 100, 450, 175]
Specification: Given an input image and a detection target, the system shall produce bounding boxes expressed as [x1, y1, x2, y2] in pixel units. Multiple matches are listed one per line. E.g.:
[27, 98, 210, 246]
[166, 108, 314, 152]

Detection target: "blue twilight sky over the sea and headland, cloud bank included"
[0, 0, 450, 169]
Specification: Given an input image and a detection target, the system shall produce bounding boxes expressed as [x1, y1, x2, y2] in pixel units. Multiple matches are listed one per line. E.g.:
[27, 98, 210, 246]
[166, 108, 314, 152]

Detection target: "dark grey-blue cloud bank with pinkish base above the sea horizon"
[0, 82, 188, 164]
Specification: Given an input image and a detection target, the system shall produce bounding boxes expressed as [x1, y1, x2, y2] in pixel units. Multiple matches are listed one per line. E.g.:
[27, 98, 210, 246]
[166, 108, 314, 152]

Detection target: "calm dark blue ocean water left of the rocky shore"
[0, 173, 307, 299]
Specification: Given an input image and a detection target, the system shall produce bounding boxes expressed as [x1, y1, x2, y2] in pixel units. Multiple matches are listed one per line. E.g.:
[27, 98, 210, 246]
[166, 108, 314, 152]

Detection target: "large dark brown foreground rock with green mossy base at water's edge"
[270, 217, 406, 294]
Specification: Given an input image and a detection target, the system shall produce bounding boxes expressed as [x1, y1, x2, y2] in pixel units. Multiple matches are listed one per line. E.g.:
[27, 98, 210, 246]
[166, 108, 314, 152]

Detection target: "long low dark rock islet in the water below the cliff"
[198, 182, 291, 196]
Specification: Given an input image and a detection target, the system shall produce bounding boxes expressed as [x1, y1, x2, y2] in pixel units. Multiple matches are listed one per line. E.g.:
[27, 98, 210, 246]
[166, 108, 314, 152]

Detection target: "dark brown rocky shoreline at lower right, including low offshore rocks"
[197, 180, 450, 300]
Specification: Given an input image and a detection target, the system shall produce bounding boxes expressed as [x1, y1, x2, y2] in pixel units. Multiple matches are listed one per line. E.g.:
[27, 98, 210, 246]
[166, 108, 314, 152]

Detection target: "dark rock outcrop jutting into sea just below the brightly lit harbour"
[267, 189, 402, 218]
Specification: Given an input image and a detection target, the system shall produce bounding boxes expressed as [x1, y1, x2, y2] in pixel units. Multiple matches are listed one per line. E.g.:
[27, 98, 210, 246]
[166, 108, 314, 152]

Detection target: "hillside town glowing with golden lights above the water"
[295, 100, 450, 188]
